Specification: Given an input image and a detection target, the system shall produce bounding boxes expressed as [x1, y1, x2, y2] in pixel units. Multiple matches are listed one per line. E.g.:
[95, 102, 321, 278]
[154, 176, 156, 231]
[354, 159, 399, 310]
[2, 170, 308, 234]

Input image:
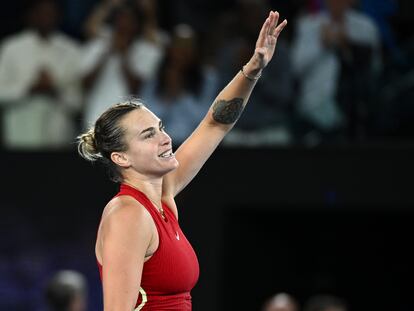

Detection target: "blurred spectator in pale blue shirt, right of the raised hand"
[292, 0, 380, 144]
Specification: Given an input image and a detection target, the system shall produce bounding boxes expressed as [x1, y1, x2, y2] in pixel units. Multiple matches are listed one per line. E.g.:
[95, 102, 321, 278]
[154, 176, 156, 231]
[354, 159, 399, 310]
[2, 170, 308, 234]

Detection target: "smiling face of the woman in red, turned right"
[111, 107, 178, 178]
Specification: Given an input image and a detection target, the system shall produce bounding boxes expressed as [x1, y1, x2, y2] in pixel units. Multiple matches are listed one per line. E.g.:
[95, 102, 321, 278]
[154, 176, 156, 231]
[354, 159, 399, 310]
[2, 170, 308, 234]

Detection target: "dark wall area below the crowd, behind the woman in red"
[0, 144, 414, 311]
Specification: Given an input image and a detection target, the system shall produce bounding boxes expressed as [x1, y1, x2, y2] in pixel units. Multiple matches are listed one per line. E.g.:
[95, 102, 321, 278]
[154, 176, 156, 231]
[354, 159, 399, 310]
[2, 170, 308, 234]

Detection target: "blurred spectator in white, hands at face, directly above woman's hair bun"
[82, 3, 164, 128]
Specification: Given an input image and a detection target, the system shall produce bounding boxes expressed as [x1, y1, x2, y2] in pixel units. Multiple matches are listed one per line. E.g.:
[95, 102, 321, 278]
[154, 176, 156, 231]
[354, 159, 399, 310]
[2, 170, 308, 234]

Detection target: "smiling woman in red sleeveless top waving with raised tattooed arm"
[78, 12, 287, 311]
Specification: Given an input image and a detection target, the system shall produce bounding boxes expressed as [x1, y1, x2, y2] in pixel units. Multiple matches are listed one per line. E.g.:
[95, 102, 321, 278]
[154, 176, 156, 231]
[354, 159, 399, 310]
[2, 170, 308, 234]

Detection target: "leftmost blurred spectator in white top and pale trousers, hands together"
[0, 0, 81, 149]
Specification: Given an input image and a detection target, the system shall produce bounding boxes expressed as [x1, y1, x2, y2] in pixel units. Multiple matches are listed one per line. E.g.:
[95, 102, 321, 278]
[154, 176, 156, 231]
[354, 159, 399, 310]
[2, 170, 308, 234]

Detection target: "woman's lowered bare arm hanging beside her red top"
[100, 196, 152, 311]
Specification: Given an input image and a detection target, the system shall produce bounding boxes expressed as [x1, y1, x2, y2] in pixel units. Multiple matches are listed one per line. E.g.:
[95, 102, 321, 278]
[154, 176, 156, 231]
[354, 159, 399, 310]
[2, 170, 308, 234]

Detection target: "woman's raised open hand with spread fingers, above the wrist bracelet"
[254, 11, 287, 68]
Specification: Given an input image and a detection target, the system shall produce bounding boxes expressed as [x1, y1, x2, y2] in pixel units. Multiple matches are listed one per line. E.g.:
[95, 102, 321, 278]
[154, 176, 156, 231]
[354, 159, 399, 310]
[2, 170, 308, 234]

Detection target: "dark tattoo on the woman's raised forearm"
[213, 98, 243, 124]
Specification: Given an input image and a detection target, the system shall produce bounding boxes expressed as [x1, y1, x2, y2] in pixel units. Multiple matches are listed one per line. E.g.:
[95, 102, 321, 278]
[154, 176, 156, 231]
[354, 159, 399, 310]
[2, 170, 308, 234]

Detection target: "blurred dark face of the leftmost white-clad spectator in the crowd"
[30, 0, 59, 35]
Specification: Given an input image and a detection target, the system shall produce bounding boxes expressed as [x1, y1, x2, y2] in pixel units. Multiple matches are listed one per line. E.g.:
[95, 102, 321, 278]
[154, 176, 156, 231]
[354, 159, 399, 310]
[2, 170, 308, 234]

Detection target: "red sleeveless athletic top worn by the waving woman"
[98, 184, 199, 311]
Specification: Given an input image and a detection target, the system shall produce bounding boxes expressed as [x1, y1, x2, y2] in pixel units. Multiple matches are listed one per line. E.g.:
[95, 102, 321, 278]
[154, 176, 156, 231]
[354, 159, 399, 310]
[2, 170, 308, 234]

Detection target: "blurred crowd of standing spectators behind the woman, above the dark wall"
[0, 0, 414, 150]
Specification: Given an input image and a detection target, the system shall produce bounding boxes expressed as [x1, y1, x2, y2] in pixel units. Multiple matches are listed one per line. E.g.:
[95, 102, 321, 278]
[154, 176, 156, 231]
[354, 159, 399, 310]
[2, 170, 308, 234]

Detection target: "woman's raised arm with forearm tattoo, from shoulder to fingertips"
[163, 11, 287, 197]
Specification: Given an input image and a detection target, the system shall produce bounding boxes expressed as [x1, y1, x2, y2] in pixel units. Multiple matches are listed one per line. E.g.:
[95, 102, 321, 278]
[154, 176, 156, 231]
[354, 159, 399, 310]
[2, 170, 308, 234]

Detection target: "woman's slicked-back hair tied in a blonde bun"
[77, 99, 144, 182]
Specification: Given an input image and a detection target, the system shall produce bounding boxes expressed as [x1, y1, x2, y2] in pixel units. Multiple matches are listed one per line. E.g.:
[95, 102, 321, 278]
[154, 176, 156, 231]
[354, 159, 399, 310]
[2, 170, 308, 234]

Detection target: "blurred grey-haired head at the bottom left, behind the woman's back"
[45, 270, 88, 311]
